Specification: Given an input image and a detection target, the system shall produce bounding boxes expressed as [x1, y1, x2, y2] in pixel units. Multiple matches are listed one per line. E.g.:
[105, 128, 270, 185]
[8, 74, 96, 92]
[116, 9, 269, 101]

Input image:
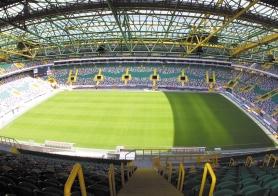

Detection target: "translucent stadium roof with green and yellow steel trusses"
[0, 0, 278, 61]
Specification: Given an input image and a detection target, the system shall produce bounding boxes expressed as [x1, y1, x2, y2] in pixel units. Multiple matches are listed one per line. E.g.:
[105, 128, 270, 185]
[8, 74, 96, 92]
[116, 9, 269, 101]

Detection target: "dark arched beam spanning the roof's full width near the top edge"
[0, 0, 278, 28]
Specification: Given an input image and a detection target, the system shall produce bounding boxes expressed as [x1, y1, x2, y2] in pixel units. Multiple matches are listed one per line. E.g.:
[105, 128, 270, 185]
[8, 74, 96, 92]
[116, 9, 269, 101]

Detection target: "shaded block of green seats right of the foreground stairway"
[161, 154, 278, 196]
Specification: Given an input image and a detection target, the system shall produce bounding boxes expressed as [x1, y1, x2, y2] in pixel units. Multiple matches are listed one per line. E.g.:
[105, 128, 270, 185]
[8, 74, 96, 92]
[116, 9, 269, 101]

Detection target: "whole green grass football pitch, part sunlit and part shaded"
[0, 91, 274, 149]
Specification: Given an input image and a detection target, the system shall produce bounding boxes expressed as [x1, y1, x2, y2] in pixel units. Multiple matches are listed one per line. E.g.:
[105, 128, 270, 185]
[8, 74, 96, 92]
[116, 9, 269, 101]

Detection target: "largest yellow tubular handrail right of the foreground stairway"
[199, 163, 216, 196]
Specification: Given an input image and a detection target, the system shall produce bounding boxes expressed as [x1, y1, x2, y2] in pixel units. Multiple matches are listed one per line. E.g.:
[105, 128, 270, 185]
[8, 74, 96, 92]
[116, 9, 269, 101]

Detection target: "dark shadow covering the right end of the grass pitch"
[164, 92, 274, 149]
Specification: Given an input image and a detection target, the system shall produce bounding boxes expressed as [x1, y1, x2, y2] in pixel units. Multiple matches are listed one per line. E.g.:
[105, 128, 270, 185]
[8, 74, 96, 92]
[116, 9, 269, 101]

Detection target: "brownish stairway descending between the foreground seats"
[118, 168, 183, 196]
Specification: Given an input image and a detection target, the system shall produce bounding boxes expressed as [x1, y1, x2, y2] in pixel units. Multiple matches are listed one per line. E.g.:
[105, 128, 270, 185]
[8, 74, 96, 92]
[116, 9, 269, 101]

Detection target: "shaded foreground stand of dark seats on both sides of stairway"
[0, 147, 278, 196]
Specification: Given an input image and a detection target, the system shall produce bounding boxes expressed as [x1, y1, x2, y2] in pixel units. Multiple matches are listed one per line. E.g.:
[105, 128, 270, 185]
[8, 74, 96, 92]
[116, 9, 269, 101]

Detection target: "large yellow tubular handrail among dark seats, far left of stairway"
[64, 163, 87, 196]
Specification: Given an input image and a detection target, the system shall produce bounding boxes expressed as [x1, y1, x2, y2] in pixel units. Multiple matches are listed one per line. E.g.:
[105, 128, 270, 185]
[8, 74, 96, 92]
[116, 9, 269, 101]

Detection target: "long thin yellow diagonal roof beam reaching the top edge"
[187, 0, 260, 55]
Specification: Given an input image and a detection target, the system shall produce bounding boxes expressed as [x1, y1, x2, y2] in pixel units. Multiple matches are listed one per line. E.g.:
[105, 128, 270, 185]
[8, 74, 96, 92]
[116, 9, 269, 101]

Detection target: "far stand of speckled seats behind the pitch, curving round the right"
[48, 65, 278, 120]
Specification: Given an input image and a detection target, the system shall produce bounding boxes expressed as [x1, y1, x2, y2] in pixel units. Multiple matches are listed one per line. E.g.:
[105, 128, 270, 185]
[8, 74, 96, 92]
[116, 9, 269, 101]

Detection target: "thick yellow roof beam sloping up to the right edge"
[231, 33, 278, 57]
